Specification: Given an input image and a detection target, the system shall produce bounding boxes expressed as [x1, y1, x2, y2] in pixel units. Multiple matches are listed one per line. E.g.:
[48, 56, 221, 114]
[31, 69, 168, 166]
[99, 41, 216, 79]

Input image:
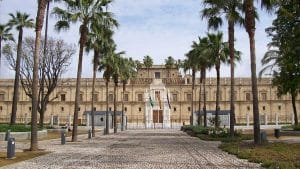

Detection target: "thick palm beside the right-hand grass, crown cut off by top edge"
[244, 0, 277, 145]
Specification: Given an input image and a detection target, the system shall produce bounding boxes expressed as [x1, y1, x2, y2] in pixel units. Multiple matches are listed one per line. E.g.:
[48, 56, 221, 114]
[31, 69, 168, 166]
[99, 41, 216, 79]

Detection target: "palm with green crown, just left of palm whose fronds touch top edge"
[207, 32, 229, 128]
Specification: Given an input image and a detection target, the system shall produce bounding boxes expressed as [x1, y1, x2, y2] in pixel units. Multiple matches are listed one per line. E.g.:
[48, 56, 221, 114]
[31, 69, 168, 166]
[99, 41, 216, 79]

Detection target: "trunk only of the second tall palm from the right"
[228, 20, 235, 137]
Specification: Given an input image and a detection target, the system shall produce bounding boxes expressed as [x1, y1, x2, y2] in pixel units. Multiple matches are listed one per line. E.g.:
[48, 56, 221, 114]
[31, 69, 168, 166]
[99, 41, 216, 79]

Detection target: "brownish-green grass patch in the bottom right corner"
[220, 142, 300, 169]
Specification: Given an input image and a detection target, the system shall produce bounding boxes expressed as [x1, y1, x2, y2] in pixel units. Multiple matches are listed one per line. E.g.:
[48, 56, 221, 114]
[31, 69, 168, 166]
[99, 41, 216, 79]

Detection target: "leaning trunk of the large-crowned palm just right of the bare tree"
[72, 25, 88, 142]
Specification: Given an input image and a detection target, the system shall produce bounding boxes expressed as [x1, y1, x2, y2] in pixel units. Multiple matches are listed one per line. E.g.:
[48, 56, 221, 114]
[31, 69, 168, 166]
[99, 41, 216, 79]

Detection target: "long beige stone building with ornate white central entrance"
[0, 65, 300, 127]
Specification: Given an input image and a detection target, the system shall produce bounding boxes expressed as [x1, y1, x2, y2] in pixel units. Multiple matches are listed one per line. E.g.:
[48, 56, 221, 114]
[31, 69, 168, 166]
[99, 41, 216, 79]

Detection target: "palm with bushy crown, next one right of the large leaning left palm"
[86, 19, 114, 137]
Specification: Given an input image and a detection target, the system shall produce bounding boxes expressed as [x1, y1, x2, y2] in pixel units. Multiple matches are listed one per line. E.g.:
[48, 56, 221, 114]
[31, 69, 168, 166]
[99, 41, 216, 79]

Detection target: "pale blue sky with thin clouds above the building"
[0, 0, 273, 78]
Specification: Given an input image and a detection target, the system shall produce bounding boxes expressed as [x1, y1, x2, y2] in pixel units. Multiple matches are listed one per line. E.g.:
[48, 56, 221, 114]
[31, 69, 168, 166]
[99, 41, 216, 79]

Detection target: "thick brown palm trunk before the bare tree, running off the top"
[30, 0, 47, 151]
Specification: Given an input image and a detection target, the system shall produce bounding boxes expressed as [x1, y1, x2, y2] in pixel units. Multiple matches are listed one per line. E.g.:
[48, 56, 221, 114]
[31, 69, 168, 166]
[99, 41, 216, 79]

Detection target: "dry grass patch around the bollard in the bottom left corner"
[0, 151, 50, 167]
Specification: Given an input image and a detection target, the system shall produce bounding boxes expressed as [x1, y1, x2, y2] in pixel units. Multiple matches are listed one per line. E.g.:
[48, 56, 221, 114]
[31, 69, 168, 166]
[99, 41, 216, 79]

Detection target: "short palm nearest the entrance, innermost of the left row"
[120, 58, 137, 131]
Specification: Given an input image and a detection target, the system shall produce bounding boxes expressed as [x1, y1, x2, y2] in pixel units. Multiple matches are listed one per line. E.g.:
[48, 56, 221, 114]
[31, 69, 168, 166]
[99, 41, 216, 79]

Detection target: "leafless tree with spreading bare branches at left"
[3, 37, 76, 127]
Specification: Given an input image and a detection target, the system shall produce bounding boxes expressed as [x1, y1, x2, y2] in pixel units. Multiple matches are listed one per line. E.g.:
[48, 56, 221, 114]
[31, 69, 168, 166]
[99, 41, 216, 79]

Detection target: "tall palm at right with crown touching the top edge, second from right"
[202, 0, 244, 136]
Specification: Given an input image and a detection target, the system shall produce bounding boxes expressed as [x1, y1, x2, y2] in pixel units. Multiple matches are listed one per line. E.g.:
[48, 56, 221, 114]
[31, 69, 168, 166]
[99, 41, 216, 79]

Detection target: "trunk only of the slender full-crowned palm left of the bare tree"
[10, 28, 23, 125]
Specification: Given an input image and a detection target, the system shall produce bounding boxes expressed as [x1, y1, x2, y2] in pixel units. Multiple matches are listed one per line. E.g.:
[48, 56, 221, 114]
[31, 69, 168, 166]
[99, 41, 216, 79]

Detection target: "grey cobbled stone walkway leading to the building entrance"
[3, 129, 261, 169]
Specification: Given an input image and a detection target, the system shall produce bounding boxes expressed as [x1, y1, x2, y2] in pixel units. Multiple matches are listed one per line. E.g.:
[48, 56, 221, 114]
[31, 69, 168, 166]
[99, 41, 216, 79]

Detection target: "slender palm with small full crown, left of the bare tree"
[8, 12, 33, 124]
